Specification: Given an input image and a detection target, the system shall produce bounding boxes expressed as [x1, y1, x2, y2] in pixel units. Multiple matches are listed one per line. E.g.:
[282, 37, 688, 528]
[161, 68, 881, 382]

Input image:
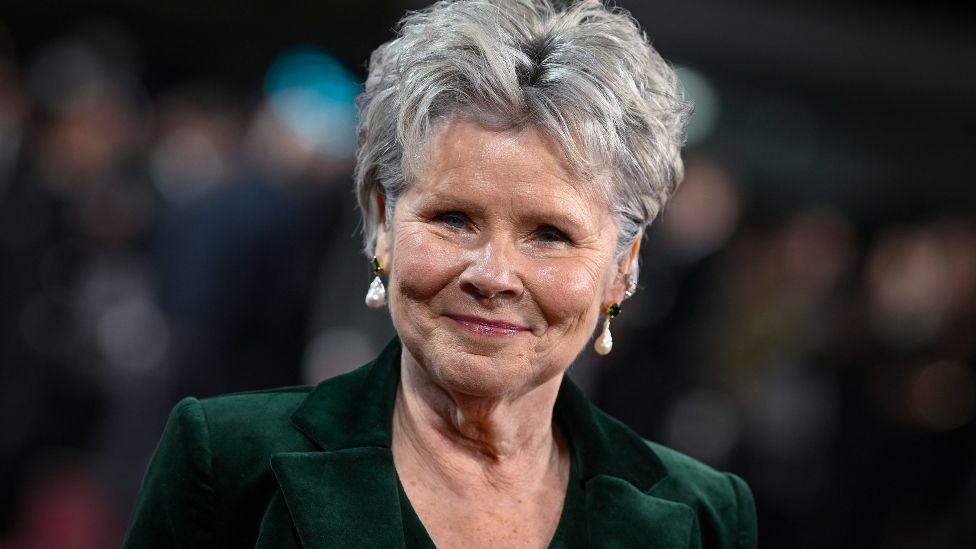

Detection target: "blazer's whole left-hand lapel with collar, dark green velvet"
[271, 339, 404, 548]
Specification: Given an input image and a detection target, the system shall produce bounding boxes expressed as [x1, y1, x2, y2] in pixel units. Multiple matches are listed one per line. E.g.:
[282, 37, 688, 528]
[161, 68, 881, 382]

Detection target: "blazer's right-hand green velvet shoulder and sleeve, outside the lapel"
[644, 440, 757, 547]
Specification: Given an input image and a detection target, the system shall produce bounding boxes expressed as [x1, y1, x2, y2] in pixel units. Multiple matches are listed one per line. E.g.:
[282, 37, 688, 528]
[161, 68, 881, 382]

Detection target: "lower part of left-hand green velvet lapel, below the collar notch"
[271, 447, 404, 548]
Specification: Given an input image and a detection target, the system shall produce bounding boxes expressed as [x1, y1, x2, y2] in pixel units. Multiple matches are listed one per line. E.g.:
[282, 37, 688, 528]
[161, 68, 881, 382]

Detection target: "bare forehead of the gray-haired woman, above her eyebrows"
[410, 120, 608, 214]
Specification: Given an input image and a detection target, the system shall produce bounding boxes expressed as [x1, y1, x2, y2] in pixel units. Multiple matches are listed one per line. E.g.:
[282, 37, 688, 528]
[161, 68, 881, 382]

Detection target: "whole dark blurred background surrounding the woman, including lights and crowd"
[0, 0, 976, 549]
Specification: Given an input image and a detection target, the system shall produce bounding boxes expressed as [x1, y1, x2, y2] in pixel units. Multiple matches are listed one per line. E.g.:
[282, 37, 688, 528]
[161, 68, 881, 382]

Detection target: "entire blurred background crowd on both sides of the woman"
[0, 18, 976, 548]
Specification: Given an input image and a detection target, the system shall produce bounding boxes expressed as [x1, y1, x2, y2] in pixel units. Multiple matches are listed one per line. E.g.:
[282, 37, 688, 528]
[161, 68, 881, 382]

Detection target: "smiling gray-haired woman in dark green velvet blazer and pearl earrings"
[126, 0, 756, 547]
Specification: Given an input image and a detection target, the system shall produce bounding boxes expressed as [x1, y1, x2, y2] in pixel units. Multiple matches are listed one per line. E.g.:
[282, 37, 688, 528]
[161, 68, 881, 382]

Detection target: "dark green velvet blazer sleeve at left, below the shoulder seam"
[123, 397, 215, 548]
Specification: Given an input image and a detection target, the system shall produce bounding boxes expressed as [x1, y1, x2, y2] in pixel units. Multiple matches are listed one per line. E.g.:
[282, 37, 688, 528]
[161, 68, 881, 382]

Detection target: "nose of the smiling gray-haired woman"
[460, 240, 523, 299]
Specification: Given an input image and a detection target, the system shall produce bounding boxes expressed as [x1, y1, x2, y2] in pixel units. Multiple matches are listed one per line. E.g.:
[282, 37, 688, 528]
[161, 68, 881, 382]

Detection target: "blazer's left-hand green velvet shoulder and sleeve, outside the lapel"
[124, 387, 311, 547]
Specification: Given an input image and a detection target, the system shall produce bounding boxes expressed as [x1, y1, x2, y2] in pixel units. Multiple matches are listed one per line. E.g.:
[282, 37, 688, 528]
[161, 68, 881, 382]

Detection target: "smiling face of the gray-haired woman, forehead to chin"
[377, 121, 637, 396]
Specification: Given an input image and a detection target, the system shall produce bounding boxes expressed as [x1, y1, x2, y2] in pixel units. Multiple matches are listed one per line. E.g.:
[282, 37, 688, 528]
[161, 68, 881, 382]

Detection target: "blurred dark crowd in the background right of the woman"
[596, 157, 976, 548]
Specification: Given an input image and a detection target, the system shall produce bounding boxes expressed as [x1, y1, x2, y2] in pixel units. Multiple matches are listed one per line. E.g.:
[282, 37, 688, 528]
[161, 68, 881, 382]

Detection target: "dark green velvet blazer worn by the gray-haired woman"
[124, 340, 756, 549]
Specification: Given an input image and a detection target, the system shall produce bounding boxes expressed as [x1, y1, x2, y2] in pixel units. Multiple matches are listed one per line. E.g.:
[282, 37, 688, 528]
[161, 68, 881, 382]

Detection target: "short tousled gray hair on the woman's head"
[355, 0, 691, 272]
